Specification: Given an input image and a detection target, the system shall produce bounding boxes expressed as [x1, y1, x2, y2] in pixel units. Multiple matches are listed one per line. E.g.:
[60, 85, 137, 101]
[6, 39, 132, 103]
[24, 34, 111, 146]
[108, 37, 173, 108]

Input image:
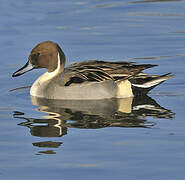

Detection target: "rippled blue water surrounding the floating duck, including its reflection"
[0, 0, 185, 180]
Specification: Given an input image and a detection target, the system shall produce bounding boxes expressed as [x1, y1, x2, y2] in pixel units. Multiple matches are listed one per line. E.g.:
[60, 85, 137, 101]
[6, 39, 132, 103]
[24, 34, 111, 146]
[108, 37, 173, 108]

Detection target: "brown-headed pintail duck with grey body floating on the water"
[12, 41, 173, 100]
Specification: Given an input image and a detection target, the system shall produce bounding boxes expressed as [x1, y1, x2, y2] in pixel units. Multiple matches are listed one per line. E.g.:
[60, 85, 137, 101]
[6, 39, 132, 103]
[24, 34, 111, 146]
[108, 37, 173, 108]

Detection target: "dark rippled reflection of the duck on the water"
[14, 96, 174, 153]
